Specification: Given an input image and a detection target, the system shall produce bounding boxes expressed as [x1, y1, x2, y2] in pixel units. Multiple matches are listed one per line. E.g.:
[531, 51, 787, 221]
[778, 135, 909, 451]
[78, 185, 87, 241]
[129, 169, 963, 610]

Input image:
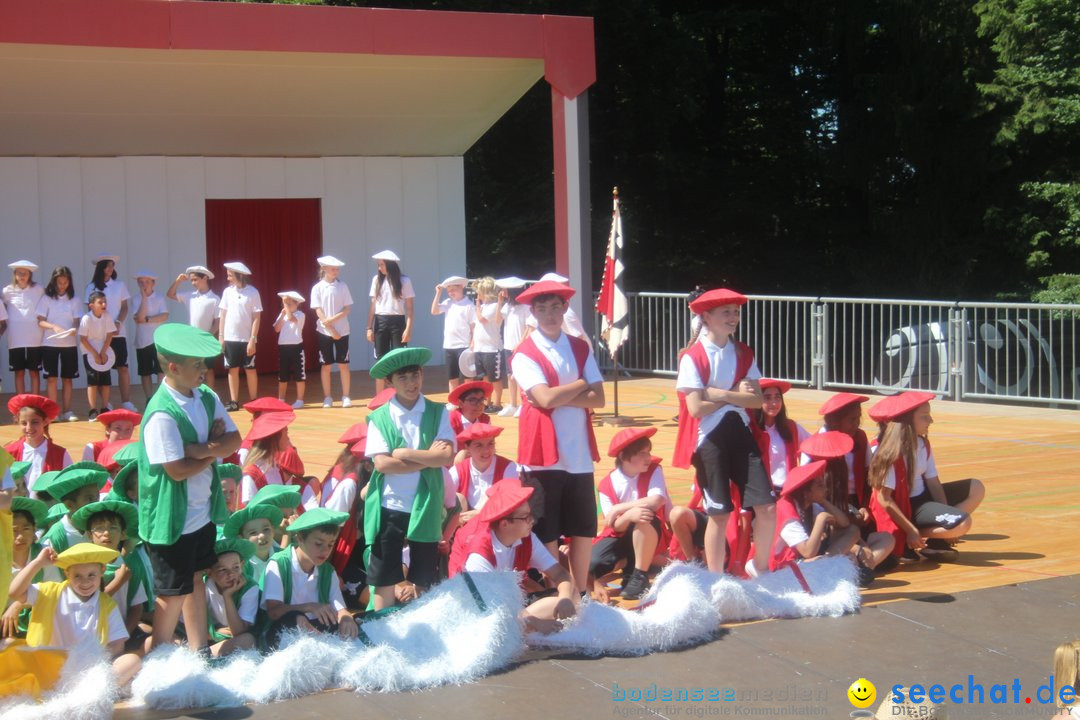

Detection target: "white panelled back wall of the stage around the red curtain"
[0, 157, 465, 393]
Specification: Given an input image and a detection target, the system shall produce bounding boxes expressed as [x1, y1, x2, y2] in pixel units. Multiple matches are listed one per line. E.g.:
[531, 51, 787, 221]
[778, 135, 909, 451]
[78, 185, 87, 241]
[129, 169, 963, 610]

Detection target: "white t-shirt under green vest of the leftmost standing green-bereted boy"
[143, 382, 237, 534]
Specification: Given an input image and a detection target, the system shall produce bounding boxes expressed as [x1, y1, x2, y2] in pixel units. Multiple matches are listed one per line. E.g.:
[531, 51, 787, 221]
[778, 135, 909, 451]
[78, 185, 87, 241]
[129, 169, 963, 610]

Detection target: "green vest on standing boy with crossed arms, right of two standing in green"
[364, 398, 446, 547]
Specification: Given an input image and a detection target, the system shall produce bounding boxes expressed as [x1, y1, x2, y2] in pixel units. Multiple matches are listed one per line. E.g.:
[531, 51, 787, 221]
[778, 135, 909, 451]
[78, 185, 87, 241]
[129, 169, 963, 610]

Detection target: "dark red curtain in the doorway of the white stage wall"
[206, 198, 323, 372]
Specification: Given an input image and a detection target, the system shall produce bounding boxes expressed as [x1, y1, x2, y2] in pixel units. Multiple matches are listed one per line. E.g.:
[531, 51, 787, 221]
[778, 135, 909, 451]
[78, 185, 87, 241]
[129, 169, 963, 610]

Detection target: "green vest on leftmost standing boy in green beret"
[138, 383, 229, 545]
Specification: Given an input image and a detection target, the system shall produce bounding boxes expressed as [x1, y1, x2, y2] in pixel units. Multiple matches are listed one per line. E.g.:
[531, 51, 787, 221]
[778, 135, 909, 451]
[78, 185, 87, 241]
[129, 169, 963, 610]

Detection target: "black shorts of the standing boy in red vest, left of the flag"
[522, 470, 596, 543]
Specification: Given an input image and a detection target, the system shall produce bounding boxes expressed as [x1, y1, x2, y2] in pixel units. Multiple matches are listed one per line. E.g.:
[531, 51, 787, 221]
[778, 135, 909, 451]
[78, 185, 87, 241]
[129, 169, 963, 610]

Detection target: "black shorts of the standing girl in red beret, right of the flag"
[691, 412, 777, 515]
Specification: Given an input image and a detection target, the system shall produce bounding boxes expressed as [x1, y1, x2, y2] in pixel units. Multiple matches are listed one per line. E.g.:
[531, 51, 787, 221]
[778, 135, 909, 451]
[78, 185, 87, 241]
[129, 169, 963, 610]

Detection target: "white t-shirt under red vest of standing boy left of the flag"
[512, 331, 604, 473]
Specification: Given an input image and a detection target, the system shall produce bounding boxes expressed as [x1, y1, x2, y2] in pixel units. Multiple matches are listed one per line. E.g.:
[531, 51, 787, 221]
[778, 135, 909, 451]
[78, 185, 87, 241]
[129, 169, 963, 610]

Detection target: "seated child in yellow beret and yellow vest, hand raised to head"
[11, 543, 141, 688]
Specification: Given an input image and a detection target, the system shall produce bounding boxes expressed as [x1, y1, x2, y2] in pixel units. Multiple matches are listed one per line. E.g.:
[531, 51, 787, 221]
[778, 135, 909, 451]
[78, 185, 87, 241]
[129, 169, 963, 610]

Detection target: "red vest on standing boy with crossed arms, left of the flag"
[511, 335, 600, 467]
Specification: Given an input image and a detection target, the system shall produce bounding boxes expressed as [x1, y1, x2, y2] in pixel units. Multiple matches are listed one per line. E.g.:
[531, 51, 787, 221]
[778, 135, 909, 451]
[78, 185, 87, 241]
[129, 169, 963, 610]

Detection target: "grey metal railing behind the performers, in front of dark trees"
[596, 293, 1080, 407]
